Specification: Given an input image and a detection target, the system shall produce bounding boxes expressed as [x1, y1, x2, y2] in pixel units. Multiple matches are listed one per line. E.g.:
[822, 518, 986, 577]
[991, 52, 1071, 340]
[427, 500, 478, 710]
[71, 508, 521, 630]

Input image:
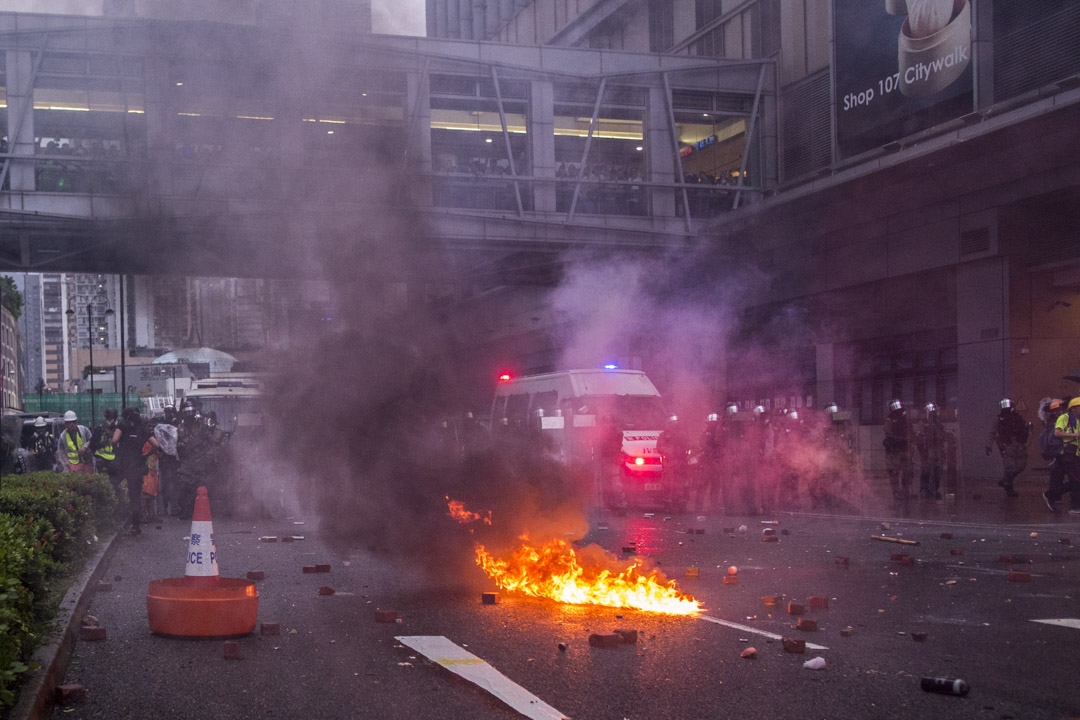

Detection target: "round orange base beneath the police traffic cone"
[146, 578, 259, 638]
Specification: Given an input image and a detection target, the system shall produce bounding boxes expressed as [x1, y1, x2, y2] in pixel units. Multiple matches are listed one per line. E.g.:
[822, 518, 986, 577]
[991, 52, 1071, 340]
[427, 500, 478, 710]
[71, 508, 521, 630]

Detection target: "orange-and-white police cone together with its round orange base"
[146, 488, 259, 638]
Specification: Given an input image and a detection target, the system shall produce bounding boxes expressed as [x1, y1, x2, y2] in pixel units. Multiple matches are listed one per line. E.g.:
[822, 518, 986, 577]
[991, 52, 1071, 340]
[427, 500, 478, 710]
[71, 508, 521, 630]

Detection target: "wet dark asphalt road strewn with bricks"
[53, 500, 1080, 720]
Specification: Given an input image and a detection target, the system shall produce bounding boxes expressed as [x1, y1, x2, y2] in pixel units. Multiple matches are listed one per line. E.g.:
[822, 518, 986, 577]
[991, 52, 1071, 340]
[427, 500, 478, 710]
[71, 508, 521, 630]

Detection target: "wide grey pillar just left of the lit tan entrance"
[956, 257, 1010, 480]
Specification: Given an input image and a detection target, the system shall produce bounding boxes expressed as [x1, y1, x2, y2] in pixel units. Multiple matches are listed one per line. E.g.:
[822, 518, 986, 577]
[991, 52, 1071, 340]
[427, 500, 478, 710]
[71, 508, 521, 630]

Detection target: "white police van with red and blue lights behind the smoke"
[491, 367, 666, 504]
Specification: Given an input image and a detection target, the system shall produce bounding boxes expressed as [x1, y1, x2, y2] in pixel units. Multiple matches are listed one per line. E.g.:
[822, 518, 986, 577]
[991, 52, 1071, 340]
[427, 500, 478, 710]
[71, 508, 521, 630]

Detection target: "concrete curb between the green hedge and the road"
[6, 533, 119, 720]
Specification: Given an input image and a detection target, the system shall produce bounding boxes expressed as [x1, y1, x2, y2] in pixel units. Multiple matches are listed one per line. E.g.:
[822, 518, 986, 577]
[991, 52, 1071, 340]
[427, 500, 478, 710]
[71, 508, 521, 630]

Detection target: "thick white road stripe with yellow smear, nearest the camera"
[394, 635, 569, 720]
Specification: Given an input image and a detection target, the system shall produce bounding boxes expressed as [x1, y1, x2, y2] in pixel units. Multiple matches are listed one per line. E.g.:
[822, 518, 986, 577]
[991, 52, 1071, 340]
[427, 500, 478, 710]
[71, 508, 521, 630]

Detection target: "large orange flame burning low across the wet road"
[476, 538, 702, 615]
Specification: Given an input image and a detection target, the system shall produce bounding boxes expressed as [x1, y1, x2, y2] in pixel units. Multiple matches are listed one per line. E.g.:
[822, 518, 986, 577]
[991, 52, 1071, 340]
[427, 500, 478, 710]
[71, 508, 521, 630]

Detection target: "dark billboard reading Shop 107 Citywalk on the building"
[833, 0, 973, 158]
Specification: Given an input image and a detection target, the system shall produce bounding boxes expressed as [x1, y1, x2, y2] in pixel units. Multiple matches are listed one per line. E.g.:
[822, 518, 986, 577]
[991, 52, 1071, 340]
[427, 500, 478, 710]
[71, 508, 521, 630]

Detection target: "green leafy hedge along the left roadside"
[0, 473, 119, 707]
